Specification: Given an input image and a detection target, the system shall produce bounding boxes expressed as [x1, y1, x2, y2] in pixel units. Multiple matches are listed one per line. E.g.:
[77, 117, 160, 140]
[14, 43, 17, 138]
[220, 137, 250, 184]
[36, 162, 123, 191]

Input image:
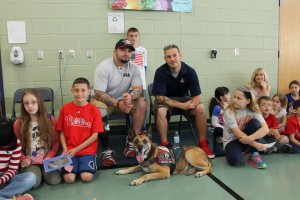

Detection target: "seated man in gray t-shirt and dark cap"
[92, 39, 147, 166]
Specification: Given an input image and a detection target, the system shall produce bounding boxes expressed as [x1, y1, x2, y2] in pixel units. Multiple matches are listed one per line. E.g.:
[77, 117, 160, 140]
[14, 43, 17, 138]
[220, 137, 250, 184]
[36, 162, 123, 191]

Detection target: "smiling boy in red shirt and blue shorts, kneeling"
[56, 78, 104, 183]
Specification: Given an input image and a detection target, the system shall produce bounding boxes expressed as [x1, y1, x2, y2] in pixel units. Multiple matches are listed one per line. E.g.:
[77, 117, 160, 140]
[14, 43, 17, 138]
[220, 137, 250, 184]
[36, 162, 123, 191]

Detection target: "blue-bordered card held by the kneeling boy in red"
[43, 154, 72, 172]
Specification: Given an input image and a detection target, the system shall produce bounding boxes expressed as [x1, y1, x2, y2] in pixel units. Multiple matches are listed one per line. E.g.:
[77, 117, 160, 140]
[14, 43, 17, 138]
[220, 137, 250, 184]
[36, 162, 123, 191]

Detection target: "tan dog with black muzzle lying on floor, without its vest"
[116, 130, 212, 185]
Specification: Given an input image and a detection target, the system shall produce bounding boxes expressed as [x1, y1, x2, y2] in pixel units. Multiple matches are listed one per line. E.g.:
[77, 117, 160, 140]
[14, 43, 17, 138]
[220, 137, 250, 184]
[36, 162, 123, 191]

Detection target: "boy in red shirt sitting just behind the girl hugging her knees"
[257, 96, 292, 154]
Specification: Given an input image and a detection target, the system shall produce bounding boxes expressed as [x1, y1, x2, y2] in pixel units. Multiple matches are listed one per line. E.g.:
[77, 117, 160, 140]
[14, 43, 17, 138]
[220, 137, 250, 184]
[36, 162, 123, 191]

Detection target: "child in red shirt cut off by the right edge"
[285, 100, 300, 153]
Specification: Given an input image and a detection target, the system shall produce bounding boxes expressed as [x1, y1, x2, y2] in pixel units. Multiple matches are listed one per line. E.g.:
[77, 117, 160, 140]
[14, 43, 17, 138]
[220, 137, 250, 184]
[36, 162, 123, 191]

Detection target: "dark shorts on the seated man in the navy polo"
[152, 96, 194, 121]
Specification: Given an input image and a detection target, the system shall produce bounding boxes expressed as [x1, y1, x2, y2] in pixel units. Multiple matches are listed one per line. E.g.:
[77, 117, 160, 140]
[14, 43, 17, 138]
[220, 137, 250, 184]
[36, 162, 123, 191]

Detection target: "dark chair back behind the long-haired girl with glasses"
[11, 87, 54, 120]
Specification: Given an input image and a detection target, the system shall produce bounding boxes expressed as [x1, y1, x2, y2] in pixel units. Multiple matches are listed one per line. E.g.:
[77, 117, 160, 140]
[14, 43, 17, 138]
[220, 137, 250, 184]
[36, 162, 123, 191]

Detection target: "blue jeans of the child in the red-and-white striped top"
[0, 172, 36, 200]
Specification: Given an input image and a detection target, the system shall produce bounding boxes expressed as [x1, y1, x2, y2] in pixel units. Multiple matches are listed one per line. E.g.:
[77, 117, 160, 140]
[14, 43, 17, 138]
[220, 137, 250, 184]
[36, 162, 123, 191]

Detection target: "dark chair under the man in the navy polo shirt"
[147, 83, 198, 146]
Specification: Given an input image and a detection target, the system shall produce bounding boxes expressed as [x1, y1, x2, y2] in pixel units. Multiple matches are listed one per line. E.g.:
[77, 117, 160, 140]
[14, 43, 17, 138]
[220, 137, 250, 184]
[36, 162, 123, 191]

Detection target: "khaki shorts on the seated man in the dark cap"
[91, 97, 145, 117]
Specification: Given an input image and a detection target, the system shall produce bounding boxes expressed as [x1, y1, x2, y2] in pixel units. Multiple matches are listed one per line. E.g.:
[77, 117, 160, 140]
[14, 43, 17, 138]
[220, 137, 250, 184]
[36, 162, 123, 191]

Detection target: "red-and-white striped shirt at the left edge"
[0, 140, 21, 185]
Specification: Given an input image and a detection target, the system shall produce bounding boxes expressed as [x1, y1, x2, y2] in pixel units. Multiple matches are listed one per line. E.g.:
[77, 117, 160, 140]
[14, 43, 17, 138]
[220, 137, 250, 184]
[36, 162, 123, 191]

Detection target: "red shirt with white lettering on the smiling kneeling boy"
[56, 102, 104, 156]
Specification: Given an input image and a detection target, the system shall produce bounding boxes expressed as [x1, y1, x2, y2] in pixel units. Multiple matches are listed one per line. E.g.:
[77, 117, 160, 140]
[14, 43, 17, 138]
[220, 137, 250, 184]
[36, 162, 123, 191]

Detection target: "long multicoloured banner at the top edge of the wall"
[110, 0, 193, 12]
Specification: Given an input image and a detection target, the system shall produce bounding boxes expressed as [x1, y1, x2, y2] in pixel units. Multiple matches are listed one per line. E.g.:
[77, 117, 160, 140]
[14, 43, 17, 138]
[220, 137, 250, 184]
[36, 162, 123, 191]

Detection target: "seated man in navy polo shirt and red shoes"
[152, 44, 215, 158]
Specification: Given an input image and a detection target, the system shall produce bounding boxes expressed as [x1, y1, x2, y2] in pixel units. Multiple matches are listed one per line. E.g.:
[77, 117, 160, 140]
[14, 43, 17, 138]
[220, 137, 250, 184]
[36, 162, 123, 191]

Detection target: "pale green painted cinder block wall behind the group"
[0, 0, 279, 120]
